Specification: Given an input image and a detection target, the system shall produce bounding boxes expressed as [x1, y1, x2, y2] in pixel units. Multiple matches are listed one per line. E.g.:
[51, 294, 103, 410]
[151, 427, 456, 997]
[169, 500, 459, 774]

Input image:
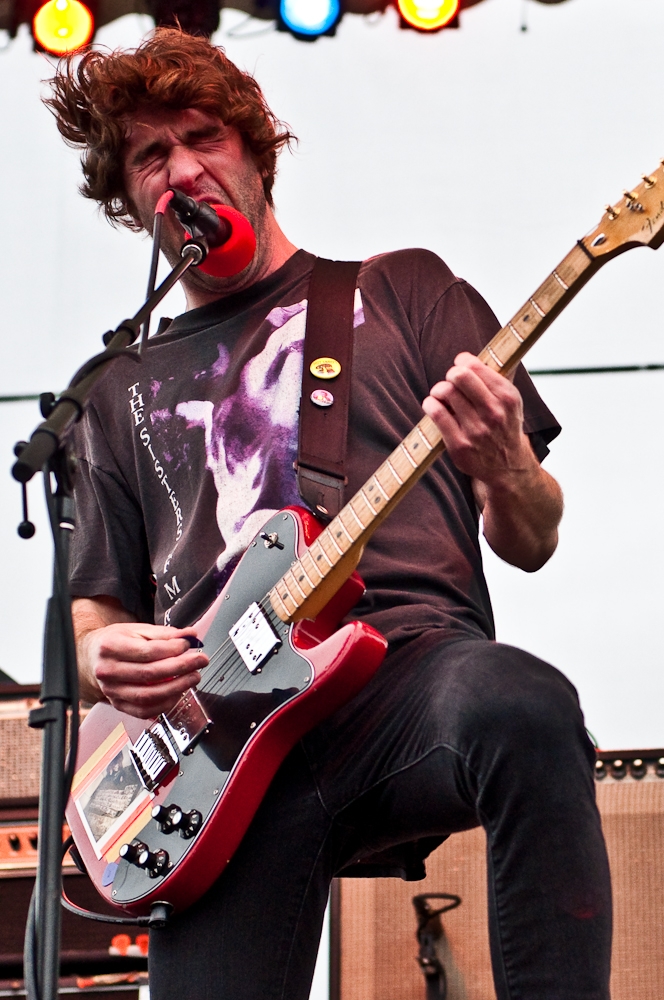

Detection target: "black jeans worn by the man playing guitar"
[150, 634, 611, 1000]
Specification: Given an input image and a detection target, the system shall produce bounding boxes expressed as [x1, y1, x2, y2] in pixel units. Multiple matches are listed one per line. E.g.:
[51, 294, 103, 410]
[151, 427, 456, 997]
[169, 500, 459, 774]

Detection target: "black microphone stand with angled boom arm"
[12, 240, 207, 1000]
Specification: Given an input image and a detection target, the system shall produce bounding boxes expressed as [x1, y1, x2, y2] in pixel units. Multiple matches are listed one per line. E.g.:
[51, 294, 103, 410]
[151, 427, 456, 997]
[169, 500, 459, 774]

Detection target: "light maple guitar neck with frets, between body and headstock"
[269, 243, 604, 623]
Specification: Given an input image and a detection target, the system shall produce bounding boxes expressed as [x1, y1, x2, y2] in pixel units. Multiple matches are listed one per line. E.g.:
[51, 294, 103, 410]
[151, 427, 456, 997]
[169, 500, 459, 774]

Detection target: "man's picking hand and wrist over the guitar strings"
[73, 598, 208, 719]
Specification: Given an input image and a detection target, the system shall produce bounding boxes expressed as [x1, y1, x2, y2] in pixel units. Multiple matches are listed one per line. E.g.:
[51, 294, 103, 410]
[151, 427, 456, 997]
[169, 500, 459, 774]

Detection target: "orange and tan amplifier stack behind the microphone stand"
[0, 684, 147, 1000]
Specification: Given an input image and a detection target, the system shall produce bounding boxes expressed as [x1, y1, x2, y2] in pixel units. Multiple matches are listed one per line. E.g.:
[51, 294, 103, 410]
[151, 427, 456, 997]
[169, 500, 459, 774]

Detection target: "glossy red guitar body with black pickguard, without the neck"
[67, 507, 387, 915]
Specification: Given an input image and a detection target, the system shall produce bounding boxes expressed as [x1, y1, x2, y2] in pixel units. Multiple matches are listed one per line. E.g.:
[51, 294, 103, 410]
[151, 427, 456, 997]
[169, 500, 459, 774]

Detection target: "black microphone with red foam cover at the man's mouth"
[169, 188, 256, 278]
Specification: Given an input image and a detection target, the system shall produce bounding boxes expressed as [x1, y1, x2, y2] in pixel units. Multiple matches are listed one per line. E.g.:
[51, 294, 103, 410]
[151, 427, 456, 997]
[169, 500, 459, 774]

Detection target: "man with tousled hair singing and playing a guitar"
[49, 29, 611, 1000]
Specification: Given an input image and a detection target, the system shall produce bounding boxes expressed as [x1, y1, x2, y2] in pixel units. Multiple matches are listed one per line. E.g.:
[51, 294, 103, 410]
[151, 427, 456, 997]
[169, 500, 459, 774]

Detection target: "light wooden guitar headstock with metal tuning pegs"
[581, 161, 664, 257]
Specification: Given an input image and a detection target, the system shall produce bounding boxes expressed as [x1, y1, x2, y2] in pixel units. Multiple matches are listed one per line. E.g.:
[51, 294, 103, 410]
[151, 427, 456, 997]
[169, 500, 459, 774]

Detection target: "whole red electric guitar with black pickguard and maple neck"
[67, 166, 664, 914]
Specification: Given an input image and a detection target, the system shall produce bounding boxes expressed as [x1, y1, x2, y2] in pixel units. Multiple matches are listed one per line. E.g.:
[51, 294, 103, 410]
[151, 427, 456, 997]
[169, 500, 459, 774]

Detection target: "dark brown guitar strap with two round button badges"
[296, 257, 361, 520]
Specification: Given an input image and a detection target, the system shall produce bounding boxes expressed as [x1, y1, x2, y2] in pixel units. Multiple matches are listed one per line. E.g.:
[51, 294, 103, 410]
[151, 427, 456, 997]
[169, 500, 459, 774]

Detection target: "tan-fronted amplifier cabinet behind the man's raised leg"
[331, 750, 664, 1000]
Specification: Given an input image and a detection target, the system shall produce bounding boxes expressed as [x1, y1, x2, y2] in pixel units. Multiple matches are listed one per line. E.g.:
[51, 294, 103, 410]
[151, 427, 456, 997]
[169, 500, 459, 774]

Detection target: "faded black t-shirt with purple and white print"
[71, 250, 560, 645]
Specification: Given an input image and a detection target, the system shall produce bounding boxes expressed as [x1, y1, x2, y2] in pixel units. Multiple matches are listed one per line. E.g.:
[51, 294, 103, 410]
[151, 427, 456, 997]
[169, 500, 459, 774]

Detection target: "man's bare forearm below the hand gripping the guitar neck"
[476, 456, 563, 573]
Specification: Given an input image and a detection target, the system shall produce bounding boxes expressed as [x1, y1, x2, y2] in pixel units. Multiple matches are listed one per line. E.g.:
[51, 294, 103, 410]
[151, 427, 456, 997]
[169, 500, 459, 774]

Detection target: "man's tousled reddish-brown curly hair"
[44, 28, 295, 229]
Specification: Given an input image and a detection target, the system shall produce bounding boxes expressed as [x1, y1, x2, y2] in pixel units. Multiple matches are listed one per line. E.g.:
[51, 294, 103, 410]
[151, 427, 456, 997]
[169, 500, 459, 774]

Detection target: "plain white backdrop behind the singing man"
[0, 0, 664, 996]
